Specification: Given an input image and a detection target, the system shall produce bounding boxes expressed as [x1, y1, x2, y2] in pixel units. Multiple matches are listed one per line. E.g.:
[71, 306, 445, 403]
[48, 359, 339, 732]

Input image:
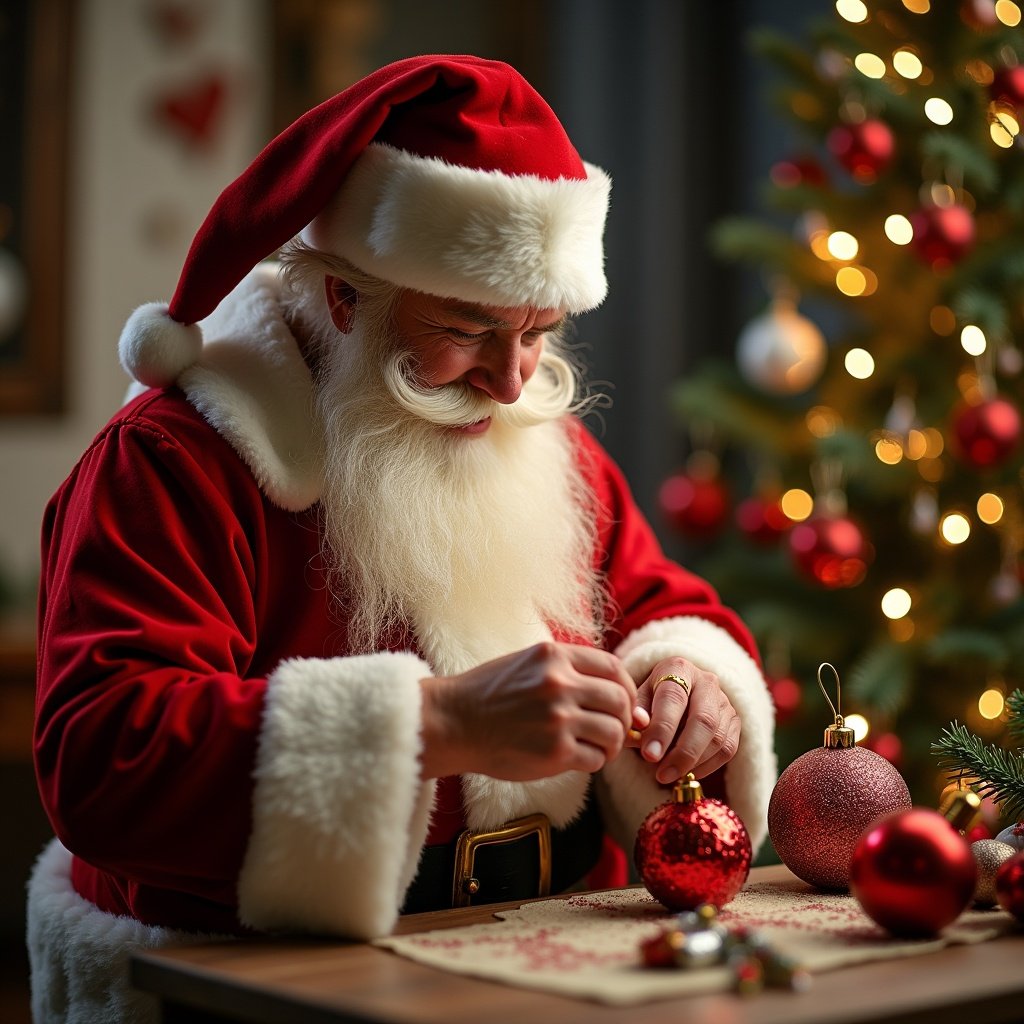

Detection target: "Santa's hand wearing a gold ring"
[630, 657, 740, 784]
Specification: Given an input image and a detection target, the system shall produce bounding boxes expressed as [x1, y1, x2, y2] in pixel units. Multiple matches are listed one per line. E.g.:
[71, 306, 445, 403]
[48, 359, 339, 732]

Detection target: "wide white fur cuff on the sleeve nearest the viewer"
[239, 652, 434, 939]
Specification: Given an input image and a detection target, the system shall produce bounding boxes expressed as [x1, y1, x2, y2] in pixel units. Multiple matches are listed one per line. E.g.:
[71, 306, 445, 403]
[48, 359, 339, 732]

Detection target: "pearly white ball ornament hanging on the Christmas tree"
[736, 299, 826, 395]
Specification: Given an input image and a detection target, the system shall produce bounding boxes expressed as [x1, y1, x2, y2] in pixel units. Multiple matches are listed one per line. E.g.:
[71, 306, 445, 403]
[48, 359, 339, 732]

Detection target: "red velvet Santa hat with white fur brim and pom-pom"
[120, 56, 610, 387]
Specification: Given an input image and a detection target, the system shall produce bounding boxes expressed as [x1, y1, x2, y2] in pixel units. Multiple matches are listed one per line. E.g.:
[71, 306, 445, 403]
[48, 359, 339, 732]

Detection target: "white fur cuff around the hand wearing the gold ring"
[600, 615, 777, 853]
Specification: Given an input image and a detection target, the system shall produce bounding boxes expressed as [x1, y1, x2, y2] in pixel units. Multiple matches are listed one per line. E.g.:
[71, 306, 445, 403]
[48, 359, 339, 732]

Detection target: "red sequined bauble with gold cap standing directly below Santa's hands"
[633, 773, 753, 911]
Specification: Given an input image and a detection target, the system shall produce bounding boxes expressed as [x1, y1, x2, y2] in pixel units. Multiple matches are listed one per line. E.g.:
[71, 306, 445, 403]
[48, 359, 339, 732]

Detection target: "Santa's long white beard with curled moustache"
[307, 313, 603, 674]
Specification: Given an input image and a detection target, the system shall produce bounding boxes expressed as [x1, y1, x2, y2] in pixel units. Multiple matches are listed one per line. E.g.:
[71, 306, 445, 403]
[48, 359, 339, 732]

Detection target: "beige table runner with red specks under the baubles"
[376, 881, 1013, 1006]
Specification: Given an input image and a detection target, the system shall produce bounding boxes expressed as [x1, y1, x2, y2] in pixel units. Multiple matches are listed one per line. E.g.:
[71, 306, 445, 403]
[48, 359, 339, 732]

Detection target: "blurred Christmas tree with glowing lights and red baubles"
[659, 0, 1024, 805]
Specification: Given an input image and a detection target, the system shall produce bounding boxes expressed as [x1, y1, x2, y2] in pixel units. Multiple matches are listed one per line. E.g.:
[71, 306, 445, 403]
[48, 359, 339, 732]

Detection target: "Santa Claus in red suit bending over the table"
[29, 56, 775, 1024]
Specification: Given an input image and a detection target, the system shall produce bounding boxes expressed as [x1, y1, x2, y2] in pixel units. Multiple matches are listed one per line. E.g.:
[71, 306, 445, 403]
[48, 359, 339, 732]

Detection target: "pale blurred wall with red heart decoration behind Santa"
[0, 0, 268, 602]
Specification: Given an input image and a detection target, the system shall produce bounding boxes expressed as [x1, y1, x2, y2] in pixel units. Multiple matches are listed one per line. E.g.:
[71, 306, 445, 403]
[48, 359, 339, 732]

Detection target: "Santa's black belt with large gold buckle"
[401, 798, 604, 913]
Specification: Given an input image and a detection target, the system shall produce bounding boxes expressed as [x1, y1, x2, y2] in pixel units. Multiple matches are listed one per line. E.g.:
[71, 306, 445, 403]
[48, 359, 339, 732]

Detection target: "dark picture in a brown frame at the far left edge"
[0, 0, 75, 417]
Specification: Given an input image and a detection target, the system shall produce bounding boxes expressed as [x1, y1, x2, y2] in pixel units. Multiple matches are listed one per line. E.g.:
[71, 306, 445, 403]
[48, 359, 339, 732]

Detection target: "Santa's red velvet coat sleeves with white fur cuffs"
[35, 266, 774, 936]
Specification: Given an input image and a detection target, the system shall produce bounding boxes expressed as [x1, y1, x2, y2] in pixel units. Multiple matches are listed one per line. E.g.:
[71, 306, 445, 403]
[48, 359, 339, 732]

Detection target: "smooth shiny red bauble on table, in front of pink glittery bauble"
[850, 807, 978, 936]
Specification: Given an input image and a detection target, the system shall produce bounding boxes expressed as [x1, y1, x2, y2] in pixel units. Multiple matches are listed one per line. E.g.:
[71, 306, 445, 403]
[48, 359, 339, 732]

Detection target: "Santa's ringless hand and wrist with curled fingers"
[422, 642, 637, 781]
